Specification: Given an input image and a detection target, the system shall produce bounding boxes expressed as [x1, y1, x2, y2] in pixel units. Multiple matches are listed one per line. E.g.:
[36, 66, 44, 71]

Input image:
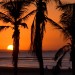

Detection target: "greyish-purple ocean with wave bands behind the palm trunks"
[0, 51, 72, 69]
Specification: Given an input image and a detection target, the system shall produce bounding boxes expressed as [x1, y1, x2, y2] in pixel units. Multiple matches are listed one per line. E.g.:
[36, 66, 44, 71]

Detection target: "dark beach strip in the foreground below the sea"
[0, 67, 72, 75]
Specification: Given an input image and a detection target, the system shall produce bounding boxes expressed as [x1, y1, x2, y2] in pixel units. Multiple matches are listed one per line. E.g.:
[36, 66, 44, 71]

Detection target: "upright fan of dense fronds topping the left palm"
[2, 0, 30, 19]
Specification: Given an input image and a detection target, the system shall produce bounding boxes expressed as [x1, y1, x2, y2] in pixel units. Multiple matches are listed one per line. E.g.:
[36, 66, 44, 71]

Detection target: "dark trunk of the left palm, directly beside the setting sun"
[13, 25, 19, 75]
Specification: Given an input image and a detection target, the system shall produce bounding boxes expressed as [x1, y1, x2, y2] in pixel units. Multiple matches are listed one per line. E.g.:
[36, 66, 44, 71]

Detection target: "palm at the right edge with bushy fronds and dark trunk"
[56, 3, 75, 75]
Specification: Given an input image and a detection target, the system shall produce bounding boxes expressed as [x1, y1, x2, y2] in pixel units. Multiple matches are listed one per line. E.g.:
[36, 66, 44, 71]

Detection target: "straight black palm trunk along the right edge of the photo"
[71, 5, 75, 75]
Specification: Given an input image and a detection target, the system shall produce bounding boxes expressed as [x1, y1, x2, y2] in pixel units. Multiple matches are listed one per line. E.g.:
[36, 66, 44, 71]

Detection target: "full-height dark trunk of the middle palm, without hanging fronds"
[35, 0, 44, 75]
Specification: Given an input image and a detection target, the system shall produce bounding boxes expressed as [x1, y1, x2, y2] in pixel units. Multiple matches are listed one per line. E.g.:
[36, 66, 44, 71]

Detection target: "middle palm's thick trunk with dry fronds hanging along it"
[31, 0, 46, 75]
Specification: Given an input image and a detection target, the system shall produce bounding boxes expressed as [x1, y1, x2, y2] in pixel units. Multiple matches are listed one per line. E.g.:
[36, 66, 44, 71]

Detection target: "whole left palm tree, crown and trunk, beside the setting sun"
[0, 0, 33, 75]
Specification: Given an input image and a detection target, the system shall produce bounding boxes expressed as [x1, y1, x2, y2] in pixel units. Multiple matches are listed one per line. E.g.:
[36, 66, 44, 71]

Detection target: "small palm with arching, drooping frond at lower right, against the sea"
[52, 43, 71, 75]
